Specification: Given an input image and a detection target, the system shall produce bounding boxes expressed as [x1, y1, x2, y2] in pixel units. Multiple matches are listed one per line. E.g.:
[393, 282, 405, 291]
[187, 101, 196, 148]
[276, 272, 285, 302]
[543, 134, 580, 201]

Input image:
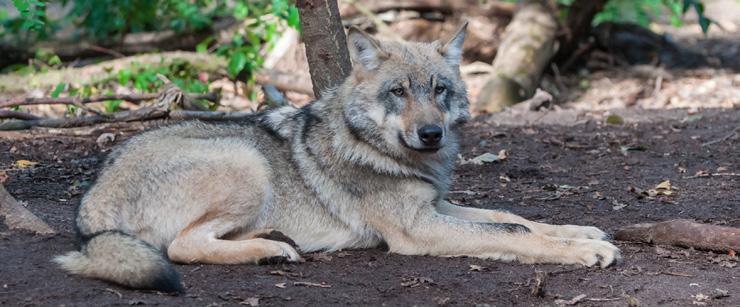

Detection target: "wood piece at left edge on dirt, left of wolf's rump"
[0, 185, 56, 235]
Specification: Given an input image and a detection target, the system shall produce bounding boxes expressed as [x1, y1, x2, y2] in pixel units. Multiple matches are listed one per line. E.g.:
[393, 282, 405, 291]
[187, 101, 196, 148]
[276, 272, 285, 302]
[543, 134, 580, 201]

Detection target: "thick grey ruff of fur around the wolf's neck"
[284, 82, 458, 197]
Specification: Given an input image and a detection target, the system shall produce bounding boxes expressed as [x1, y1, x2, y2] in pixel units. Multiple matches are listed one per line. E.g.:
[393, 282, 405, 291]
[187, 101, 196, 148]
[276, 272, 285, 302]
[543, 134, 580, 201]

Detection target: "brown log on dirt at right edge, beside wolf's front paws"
[614, 220, 740, 252]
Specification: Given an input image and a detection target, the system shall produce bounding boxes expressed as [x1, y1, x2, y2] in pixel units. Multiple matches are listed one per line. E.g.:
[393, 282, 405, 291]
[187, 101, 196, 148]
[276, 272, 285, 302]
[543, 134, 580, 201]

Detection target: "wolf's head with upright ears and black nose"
[343, 25, 470, 161]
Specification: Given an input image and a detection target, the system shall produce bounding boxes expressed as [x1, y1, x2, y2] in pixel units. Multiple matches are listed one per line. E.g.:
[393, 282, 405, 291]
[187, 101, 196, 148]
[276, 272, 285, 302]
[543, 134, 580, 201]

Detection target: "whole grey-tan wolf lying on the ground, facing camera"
[54, 25, 620, 292]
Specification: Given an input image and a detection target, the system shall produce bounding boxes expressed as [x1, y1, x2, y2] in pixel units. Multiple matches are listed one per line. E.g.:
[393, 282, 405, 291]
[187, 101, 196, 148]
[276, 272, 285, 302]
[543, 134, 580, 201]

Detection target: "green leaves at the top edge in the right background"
[588, 0, 711, 33]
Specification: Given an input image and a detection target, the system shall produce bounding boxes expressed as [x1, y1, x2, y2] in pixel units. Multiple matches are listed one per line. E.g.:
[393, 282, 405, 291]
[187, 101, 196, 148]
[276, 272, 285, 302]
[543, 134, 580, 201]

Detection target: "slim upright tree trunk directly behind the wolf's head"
[296, 0, 352, 98]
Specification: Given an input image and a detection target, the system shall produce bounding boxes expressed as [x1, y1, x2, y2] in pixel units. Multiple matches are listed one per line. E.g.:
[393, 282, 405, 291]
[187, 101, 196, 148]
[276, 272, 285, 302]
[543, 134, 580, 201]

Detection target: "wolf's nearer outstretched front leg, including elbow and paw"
[378, 206, 620, 267]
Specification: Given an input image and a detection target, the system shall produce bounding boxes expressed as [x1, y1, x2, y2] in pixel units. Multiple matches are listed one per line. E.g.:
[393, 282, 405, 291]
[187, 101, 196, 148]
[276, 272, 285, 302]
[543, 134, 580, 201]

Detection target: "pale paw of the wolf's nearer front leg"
[567, 239, 622, 268]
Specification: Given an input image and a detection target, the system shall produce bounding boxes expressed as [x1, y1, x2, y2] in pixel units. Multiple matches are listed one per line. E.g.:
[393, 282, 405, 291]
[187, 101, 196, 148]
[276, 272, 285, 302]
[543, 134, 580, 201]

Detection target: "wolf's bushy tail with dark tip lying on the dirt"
[54, 231, 183, 292]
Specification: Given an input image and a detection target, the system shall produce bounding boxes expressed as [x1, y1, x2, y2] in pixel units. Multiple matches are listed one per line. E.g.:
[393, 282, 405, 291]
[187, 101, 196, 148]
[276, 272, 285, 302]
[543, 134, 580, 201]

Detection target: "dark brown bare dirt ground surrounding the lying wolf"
[0, 108, 740, 306]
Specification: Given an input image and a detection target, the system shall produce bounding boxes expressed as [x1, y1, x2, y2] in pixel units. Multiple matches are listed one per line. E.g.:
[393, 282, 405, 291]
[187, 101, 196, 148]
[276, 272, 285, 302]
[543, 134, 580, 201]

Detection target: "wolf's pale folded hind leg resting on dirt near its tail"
[167, 225, 301, 264]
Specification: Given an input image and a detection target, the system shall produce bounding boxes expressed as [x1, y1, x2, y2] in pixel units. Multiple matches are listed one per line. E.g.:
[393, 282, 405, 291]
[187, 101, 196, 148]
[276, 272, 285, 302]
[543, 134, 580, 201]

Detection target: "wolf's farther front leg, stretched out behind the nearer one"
[436, 201, 608, 240]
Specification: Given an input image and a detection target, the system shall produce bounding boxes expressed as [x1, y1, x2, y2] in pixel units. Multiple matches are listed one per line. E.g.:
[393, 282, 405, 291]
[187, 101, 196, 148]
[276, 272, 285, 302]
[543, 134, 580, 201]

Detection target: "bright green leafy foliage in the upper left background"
[5, 0, 300, 100]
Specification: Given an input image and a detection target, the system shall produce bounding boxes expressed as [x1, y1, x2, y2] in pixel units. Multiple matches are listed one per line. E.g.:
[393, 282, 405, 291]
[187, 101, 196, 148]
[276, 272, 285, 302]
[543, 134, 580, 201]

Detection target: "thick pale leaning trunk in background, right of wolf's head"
[476, 1, 557, 113]
